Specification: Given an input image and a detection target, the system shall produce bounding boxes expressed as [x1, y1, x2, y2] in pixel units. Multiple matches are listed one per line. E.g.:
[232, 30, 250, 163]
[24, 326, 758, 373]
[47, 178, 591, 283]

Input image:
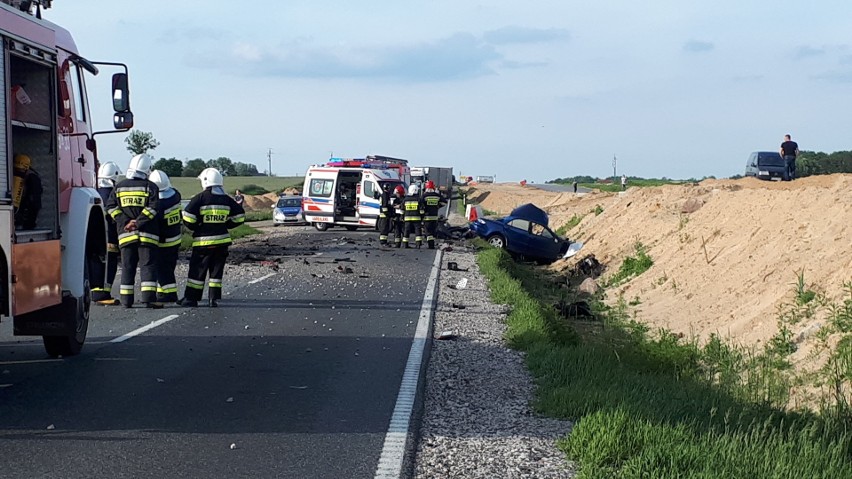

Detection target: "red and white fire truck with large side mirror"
[0, 0, 133, 356]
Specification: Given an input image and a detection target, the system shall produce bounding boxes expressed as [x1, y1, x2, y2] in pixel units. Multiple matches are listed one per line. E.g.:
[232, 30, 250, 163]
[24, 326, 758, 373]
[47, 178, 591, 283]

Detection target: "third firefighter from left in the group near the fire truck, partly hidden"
[151, 170, 181, 303]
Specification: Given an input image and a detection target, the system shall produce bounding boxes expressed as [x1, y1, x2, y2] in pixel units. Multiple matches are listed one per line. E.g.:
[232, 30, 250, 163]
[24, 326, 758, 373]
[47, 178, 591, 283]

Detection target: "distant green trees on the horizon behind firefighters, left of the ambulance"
[124, 130, 261, 178]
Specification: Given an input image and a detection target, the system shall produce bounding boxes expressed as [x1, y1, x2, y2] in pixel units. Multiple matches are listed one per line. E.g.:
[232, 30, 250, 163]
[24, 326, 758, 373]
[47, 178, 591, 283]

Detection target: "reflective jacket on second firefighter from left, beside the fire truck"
[107, 178, 160, 246]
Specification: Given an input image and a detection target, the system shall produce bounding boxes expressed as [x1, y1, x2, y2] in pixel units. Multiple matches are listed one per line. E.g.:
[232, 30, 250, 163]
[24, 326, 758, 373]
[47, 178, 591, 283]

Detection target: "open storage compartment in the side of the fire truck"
[0, 39, 59, 243]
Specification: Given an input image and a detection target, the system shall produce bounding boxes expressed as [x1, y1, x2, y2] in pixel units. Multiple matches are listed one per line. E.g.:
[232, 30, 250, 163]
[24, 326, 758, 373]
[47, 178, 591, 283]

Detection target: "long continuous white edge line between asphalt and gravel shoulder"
[374, 249, 444, 479]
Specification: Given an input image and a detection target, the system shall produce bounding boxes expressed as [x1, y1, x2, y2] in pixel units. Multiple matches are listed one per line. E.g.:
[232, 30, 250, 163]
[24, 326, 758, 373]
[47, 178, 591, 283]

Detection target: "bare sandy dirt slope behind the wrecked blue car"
[466, 175, 852, 359]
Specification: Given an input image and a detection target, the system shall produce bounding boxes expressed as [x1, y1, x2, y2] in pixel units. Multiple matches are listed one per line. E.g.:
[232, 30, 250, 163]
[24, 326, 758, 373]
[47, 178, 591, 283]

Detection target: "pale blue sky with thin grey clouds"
[44, 0, 852, 182]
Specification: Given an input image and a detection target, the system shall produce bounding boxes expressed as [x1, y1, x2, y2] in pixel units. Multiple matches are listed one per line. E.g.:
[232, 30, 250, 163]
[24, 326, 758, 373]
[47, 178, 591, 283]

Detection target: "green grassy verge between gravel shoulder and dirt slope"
[478, 248, 852, 478]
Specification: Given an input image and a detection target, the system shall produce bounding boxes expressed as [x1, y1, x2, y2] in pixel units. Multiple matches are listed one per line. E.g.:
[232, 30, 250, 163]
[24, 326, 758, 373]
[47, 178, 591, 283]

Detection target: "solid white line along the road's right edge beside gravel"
[374, 250, 443, 479]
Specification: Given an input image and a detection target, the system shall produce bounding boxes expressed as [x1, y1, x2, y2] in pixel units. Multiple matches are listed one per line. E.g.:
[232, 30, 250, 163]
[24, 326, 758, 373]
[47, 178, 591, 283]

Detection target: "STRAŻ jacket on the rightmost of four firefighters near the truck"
[182, 186, 246, 248]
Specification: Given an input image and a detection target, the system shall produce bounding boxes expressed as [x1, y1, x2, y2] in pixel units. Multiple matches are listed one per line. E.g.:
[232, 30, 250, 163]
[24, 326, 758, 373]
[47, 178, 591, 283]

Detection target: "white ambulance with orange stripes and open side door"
[302, 156, 411, 231]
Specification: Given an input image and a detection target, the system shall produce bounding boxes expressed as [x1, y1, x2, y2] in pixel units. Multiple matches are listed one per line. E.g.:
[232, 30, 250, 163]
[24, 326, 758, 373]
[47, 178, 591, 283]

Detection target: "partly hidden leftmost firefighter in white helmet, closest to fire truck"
[90, 161, 121, 306]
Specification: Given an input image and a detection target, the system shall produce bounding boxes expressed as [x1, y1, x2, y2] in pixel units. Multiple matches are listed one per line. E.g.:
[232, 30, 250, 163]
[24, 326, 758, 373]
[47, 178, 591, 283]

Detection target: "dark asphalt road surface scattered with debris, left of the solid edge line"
[0, 227, 435, 478]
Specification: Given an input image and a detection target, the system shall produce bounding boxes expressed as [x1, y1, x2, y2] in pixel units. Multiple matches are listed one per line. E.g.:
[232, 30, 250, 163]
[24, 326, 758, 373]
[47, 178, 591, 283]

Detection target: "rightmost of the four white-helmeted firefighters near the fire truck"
[178, 168, 246, 308]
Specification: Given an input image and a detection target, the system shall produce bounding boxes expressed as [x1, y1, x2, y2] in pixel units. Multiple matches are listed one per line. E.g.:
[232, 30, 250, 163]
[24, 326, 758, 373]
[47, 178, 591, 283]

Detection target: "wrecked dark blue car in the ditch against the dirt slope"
[470, 203, 571, 264]
